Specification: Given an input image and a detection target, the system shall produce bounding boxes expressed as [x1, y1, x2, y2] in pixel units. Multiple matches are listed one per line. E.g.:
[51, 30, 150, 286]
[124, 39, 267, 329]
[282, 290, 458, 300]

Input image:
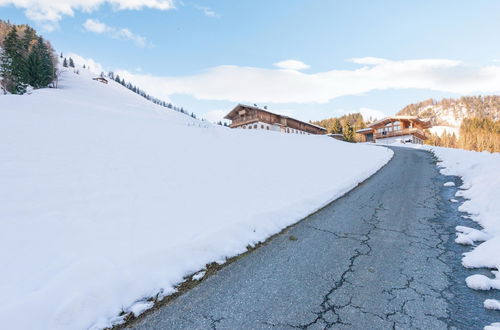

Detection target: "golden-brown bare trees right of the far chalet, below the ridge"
[426, 118, 500, 152]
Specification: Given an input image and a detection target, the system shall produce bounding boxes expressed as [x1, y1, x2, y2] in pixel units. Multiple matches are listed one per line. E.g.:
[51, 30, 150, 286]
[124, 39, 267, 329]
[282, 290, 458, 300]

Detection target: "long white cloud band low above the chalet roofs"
[114, 58, 500, 104]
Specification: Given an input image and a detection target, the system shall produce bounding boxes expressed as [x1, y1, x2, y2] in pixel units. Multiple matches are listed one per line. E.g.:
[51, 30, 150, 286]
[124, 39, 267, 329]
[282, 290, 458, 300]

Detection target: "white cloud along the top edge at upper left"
[0, 0, 175, 27]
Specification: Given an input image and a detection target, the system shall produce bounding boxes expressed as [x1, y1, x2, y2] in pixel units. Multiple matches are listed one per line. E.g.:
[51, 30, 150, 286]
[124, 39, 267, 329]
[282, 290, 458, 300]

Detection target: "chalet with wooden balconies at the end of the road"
[356, 116, 431, 144]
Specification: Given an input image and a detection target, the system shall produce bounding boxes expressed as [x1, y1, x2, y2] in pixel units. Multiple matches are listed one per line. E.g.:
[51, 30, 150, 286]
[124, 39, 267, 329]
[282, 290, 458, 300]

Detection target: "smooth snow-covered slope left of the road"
[0, 69, 394, 329]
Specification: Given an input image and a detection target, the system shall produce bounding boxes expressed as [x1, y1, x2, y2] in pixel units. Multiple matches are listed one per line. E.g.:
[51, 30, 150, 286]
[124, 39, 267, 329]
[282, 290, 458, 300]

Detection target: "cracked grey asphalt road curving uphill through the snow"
[129, 148, 499, 329]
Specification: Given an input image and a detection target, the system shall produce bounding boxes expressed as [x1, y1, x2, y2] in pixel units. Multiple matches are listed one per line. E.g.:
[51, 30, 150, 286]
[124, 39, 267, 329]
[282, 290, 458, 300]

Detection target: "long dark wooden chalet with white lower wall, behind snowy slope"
[224, 104, 326, 134]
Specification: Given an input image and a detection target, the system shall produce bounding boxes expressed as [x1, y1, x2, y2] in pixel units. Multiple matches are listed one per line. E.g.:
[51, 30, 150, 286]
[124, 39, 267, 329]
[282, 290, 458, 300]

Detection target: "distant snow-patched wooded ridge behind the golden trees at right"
[397, 95, 500, 128]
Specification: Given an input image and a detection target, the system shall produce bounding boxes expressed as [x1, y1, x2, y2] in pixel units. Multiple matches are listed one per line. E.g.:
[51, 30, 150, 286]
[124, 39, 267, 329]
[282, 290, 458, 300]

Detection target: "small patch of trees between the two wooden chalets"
[312, 113, 367, 142]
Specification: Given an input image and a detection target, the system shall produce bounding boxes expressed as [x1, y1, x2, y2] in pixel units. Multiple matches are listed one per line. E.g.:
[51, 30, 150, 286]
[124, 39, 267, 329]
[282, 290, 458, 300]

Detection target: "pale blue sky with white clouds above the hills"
[0, 0, 500, 121]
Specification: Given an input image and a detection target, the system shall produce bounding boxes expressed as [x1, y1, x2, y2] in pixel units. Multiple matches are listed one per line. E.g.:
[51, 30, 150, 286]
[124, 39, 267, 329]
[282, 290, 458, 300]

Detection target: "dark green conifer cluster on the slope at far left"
[0, 21, 57, 94]
